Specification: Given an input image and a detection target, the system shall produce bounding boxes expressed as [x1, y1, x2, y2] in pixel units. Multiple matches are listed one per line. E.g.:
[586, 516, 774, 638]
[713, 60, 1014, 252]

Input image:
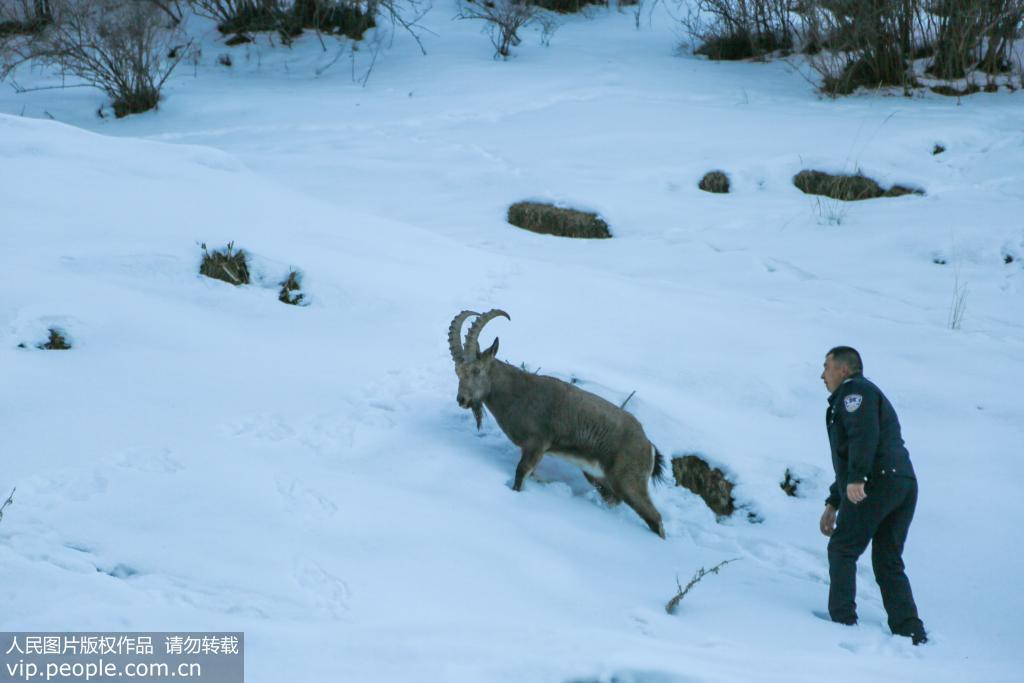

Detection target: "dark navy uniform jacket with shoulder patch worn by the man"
[825, 375, 915, 509]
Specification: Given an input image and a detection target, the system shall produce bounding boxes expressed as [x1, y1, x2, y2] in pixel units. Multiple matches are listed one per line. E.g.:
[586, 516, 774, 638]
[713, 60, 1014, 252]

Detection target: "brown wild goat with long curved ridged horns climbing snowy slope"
[449, 309, 665, 539]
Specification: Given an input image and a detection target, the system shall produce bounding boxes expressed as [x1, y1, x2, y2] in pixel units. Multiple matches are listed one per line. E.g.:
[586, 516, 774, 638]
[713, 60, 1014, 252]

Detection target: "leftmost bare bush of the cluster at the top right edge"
[683, 0, 794, 59]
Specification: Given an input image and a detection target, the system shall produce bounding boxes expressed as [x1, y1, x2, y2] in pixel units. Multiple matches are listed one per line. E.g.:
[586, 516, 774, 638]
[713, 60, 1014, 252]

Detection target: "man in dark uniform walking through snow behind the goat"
[820, 346, 928, 645]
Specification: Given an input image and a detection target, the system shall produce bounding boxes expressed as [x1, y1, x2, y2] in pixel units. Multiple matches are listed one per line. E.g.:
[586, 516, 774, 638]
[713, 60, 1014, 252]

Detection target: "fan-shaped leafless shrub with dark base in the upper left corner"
[24, 0, 190, 118]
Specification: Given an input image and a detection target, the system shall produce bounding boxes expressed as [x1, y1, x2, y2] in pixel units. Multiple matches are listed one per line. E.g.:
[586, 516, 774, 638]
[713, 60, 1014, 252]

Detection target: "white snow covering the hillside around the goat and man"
[0, 3, 1024, 683]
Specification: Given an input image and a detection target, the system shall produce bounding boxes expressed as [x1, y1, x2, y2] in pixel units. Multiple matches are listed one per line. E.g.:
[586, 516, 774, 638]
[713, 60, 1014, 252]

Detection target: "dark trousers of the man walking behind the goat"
[828, 475, 923, 635]
